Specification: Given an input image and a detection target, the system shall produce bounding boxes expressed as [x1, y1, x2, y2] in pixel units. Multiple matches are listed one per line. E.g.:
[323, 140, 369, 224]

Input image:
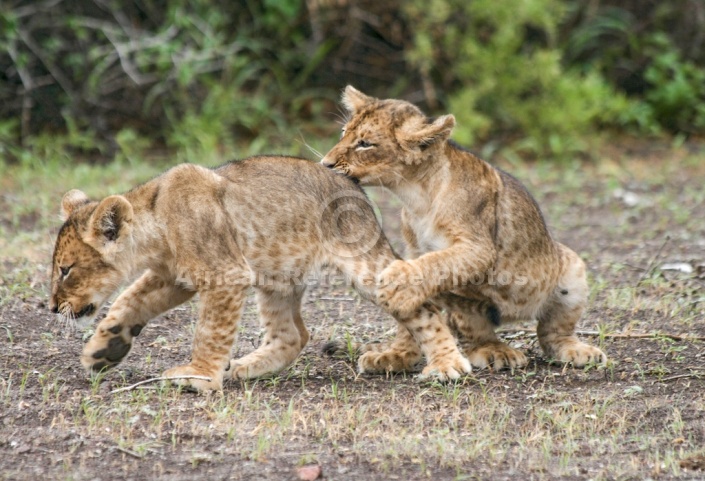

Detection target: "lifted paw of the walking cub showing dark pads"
[81, 324, 141, 373]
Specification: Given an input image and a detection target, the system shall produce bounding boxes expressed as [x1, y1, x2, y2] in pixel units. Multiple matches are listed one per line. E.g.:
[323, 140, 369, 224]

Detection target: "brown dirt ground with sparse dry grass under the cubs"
[0, 149, 705, 480]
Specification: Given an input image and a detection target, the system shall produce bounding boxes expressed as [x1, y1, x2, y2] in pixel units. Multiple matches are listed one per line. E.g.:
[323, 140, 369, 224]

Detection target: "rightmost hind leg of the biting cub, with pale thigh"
[536, 245, 607, 367]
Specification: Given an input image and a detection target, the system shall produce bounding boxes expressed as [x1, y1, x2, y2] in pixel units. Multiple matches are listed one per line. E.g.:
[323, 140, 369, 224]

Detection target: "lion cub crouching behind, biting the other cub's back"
[321, 86, 606, 369]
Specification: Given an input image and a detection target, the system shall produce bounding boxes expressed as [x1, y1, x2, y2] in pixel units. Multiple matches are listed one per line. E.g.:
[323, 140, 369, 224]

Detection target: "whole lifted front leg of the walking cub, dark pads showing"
[81, 271, 195, 373]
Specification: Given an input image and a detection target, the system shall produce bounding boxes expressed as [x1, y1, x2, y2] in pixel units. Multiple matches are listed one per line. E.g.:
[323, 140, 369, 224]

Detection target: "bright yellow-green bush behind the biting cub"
[405, 0, 629, 156]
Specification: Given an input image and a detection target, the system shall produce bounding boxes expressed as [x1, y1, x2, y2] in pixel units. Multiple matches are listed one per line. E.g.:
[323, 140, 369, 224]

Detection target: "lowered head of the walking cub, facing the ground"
[49, 190, 133, 321]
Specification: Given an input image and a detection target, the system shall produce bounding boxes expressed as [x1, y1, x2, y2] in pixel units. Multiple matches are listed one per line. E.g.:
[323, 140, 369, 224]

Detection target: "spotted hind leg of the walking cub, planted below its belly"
[225, 287, 309, 379]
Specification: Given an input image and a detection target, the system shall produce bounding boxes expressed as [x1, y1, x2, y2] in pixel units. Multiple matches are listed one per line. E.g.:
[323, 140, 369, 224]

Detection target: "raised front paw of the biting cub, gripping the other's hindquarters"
[377, 260, 427, 317]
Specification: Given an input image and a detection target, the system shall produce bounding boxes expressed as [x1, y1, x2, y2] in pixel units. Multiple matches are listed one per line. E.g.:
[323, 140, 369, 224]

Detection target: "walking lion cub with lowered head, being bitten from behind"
[50, 157, 470, 389]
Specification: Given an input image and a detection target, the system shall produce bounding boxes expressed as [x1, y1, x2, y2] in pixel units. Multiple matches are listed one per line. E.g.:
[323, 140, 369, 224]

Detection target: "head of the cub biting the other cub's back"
[321, 85, 455, 186]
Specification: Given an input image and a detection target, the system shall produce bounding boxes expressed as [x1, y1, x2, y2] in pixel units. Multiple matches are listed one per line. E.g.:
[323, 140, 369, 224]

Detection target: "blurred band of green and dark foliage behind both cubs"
[0, 0, 705, 160]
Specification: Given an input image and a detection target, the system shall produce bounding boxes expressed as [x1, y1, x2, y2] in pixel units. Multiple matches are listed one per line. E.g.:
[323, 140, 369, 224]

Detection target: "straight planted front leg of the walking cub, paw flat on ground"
[164, 285, 247, 391]
